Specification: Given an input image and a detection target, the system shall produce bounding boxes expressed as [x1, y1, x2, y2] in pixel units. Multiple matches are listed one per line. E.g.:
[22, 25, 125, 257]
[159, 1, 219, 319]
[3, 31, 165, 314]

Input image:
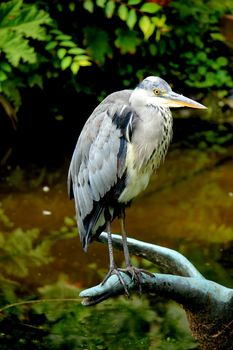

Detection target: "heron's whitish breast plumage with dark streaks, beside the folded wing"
[118, 106, 172, 203]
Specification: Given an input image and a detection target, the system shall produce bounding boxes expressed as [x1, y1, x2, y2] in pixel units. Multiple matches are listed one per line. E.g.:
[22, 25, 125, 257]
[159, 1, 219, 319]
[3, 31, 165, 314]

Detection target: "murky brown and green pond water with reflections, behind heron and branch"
[0, 146, 233, 350]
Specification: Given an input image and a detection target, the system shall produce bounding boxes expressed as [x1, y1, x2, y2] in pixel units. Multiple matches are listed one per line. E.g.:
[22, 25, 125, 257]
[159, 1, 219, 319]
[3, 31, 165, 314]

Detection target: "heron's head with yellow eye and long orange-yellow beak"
[134, 76, 207, 109]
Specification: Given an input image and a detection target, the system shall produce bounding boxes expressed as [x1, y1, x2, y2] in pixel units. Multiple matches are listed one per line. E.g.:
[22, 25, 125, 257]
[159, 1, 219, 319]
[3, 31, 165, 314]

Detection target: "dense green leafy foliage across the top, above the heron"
[0, 0, 233, 112]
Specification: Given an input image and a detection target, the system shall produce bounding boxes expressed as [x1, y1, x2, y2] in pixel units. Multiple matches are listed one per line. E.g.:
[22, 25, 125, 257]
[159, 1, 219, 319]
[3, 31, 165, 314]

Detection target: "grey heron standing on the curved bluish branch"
[68, 76, 206, 292]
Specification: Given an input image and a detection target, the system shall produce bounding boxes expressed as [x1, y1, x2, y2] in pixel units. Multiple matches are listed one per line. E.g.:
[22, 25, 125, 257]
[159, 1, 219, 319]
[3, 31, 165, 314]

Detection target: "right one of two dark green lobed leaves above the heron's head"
[115, 28, 141, 54]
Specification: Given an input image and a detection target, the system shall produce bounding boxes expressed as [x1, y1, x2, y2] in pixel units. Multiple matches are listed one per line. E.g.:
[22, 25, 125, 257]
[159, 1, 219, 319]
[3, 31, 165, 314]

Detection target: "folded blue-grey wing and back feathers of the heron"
[68, 90, 136, 248]
